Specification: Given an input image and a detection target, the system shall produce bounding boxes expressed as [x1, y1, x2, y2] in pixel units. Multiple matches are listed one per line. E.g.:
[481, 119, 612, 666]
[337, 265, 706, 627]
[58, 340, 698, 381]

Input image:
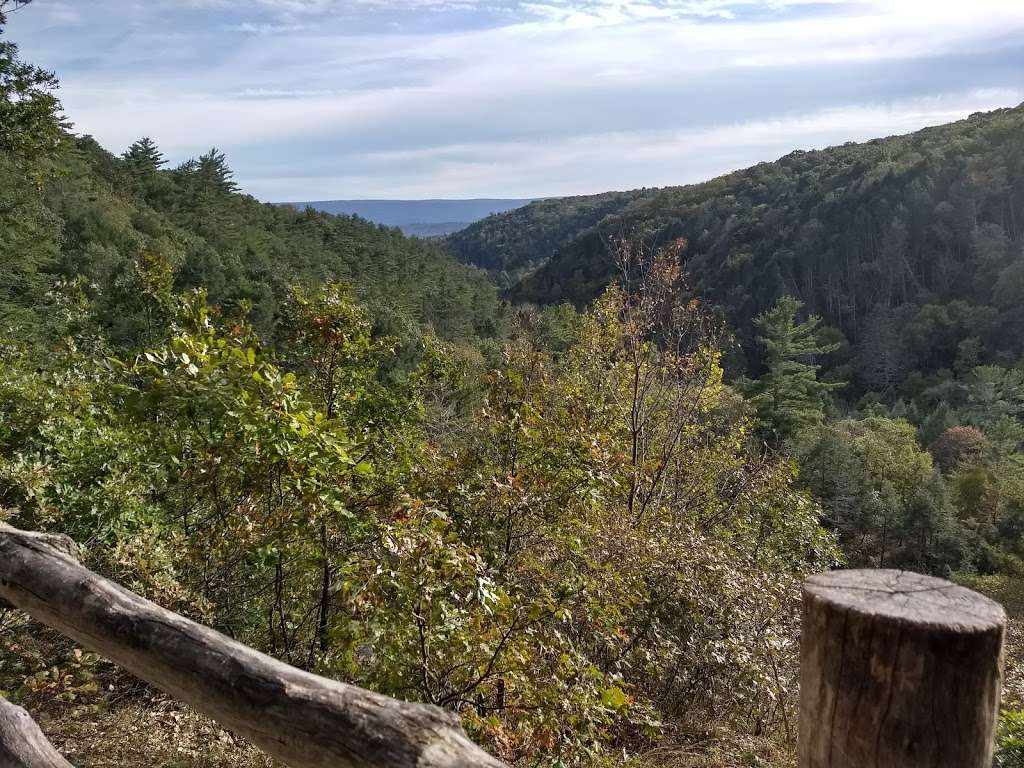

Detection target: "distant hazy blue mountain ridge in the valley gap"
[283, 198, 534, 238]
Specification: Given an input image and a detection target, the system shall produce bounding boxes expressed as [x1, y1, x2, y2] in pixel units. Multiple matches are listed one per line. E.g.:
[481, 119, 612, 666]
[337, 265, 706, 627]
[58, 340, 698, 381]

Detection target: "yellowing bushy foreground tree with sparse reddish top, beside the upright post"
[344, 247, 835, 762]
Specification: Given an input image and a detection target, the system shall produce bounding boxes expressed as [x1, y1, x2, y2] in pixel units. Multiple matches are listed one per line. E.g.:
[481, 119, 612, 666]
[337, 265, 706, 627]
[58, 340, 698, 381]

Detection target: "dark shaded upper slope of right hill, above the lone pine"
[453, 108, 1024, 390]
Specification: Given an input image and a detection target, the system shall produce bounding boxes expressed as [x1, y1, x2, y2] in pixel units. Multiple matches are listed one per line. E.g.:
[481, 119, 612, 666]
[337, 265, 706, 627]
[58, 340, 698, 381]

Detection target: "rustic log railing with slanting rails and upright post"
[0, 525, 1006, 768]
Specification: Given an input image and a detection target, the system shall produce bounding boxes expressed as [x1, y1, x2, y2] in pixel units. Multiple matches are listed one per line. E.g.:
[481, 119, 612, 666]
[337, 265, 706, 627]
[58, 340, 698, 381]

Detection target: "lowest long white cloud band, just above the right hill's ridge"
[242, 89, 1024, 200]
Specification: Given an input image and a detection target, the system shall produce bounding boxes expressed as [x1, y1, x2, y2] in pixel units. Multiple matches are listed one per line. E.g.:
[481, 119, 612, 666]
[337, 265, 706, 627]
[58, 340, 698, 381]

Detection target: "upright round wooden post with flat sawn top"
[799, 570, 1006, 768]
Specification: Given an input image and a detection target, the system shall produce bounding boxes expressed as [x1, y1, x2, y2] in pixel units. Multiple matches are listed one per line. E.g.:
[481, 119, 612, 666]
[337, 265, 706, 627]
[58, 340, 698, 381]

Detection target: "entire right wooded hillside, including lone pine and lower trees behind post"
[451, 108, 1024, 589]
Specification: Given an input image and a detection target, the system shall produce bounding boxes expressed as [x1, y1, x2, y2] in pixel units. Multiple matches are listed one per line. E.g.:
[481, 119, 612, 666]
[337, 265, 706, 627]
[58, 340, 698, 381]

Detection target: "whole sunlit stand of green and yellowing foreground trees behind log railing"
[0, 261, 837, 765]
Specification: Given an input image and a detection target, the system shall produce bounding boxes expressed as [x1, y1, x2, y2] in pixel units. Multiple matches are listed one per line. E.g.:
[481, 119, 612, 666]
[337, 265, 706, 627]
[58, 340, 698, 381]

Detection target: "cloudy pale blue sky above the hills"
[6, 0, 1024, 202]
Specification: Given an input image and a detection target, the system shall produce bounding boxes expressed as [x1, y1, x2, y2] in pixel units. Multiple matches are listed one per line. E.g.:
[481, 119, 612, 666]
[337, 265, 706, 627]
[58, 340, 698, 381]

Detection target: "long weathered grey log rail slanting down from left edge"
[0, 526, 504, 768]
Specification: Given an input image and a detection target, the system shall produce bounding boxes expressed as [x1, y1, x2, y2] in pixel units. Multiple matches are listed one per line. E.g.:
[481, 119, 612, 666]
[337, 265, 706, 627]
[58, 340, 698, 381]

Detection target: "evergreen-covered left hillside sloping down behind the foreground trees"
[0, 136, 502, 354]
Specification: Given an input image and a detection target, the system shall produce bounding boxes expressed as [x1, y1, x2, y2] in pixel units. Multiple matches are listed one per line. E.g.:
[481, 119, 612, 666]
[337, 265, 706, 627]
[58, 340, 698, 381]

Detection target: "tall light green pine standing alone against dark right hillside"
[746, 296, 843, 443]
